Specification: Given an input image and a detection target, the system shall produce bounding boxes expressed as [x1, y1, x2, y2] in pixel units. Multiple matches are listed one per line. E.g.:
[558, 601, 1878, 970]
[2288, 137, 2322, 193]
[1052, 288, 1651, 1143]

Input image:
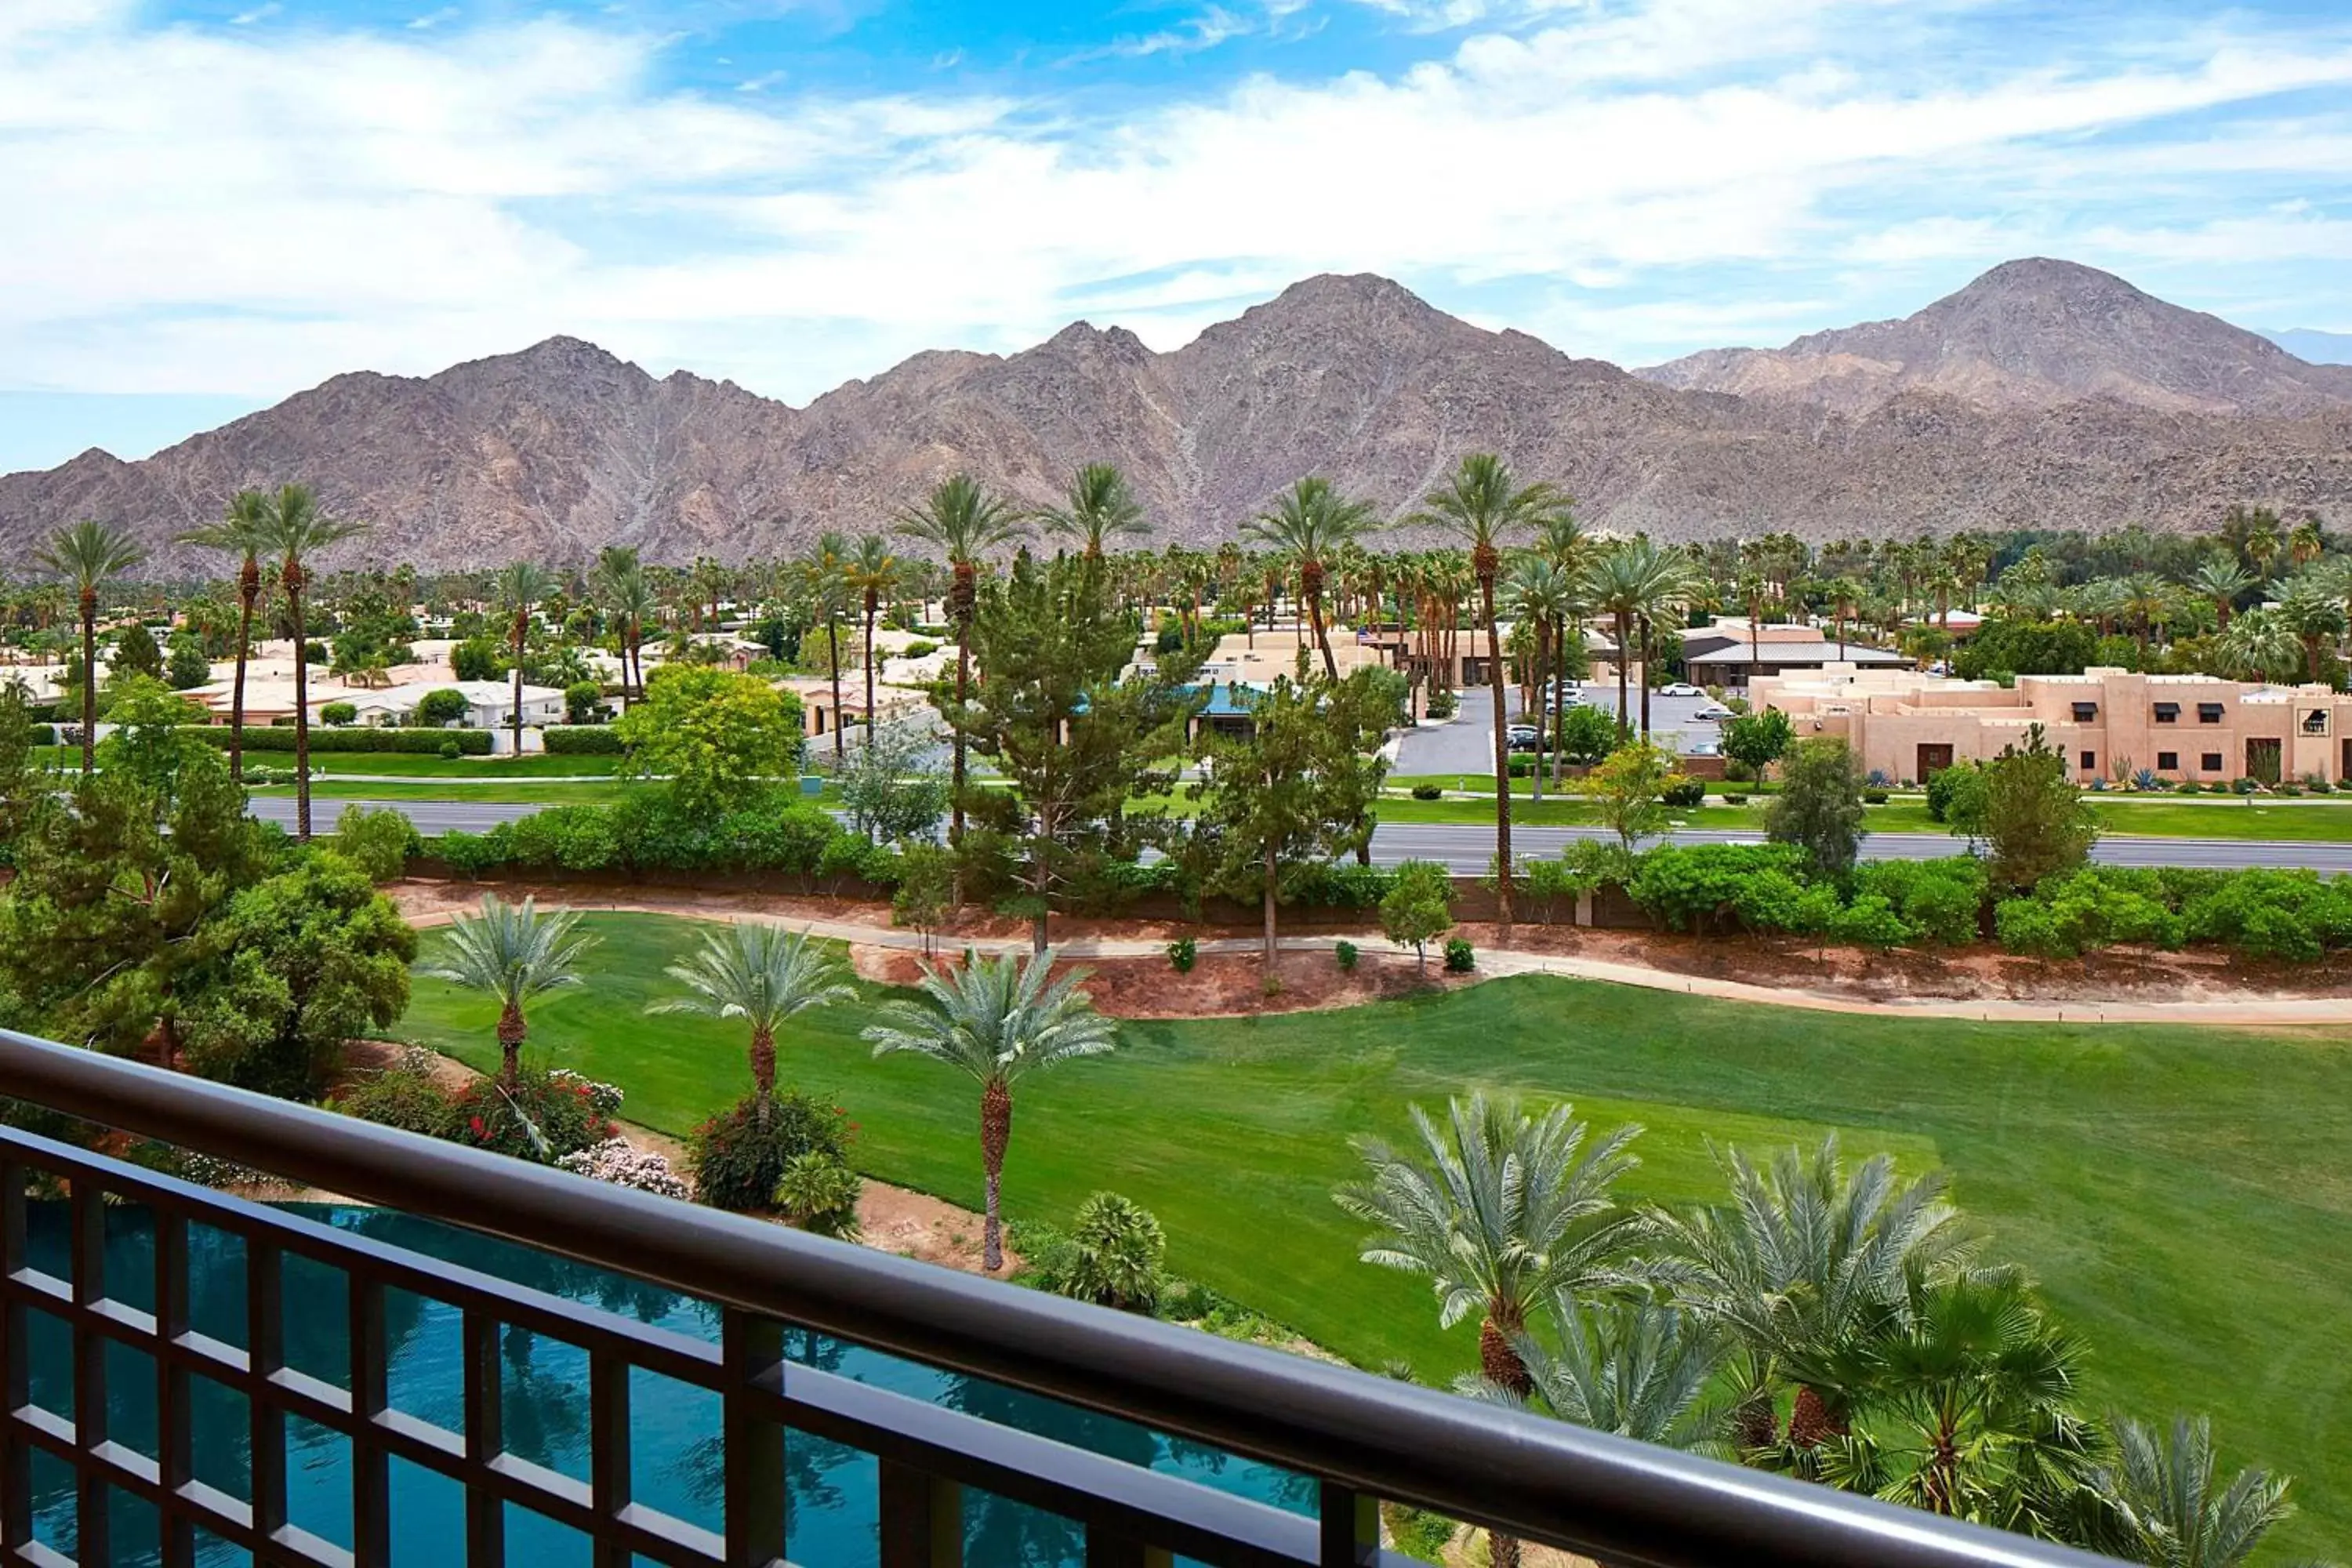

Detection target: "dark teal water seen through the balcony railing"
[28, 1203, 1312, 1568]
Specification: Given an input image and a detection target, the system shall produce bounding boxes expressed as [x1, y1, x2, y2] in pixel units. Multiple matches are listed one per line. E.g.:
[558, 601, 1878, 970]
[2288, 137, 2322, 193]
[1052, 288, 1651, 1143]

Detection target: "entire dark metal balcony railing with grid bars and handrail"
[0, 1032, 2100, 1568]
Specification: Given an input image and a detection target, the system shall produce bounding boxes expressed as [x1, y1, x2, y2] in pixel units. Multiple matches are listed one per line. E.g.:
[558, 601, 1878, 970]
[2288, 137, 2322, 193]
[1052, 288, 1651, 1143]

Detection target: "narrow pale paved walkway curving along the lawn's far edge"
[395, 893, 2352, 1027]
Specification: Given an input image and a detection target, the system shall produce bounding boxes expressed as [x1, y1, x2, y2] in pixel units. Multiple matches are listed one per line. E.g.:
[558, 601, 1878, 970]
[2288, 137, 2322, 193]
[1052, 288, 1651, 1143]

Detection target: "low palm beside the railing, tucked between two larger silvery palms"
[1456, 1295, 1733, 1460]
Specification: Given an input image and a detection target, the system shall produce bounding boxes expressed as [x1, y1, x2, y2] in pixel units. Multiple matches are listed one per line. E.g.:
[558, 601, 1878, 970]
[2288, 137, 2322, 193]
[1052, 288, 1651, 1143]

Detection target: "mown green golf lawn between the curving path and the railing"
[402, 914, 2352, 1556]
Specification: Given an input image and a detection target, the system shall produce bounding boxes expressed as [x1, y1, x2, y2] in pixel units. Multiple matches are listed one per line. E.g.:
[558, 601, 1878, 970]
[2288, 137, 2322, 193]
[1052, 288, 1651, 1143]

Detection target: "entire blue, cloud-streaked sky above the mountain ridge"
[0, 0, 2352, 470]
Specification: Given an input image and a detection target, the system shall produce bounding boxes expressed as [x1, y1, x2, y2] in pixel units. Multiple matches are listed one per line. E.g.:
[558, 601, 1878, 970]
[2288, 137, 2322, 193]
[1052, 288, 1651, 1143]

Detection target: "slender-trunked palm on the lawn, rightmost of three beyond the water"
[866, 949, 1120, 1274]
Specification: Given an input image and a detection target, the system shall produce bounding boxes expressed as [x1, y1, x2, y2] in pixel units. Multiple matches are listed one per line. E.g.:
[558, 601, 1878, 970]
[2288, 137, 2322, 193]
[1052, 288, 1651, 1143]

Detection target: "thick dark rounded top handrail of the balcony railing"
[0, 1029, 2105, 1568]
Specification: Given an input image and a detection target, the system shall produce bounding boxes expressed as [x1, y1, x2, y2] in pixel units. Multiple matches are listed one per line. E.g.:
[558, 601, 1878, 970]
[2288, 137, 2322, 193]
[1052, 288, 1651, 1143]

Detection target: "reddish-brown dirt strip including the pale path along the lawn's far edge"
[390, 881, 2352, 1027]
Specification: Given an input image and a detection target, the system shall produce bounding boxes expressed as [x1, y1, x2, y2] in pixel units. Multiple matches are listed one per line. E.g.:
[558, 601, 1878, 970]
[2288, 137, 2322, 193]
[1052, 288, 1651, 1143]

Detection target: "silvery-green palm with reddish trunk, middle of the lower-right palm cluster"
[1649, 1135, 1976, 1450]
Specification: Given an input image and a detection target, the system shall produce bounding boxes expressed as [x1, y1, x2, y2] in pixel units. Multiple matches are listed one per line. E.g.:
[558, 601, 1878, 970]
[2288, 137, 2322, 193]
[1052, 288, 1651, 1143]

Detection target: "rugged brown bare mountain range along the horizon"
[0, 259, 2352, 572]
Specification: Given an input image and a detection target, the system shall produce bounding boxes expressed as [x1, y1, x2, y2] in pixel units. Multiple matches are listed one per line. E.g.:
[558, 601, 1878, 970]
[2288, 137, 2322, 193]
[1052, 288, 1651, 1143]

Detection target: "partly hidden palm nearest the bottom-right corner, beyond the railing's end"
[2086, 1415, 2296, 1568]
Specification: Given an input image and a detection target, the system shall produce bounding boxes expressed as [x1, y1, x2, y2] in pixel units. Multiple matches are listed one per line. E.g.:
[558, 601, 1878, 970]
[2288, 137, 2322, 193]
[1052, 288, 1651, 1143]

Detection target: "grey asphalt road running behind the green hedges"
[254, 794, 2352, 874]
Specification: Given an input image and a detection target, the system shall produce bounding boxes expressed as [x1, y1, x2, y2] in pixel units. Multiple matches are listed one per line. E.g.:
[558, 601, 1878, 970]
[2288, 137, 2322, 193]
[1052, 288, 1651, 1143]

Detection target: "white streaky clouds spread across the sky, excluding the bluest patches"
[0, 0, 2352, 397]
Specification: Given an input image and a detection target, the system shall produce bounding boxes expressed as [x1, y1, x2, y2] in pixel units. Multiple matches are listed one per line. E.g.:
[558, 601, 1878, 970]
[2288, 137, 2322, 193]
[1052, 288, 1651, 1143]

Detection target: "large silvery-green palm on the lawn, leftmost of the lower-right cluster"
[1334, 1093, 1642, 1568]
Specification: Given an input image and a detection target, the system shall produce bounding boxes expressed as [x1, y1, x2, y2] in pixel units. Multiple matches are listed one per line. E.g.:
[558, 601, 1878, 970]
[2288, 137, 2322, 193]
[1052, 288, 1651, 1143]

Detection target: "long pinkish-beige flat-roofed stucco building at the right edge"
[1748, 663, 2352, 783]
